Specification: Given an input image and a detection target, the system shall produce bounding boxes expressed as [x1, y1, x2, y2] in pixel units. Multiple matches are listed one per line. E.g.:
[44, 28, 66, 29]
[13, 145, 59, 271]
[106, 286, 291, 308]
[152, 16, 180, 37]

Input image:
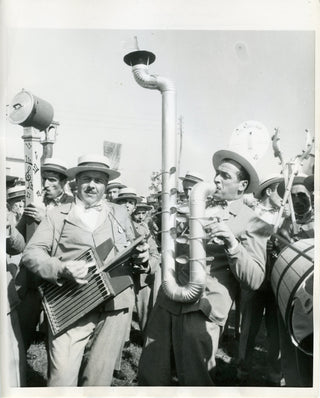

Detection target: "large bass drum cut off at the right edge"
[271, 239, 314, 355]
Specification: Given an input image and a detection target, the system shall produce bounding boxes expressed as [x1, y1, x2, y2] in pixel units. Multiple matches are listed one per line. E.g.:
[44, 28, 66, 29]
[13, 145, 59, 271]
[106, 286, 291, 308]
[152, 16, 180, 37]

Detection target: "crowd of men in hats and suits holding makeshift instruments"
[7, 150, 314, 387]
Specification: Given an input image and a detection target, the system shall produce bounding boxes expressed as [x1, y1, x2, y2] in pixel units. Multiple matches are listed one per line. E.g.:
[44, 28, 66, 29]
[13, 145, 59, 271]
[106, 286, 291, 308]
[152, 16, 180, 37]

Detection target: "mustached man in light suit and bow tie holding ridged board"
[23, 155, 149, 386]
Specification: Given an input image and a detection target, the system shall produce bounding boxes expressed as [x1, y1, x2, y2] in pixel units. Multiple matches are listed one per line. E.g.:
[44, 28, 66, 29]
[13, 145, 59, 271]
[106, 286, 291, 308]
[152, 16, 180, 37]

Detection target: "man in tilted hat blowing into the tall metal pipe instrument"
[138, 150, 270, 386]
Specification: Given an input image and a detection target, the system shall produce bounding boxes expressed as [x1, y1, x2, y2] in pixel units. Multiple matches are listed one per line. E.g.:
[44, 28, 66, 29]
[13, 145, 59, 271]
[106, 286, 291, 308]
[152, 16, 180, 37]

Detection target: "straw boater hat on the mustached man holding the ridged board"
[68, 154, 120, 180]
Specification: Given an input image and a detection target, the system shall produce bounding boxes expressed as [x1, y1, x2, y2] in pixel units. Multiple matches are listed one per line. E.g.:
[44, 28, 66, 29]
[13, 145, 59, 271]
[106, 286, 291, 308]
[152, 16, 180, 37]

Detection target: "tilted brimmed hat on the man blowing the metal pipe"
[212, 149, 259, 193]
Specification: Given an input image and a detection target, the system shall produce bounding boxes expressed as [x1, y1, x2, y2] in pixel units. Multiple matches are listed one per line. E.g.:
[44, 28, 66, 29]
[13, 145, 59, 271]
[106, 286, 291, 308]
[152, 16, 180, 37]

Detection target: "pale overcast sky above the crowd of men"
[6, 29, 315, 195]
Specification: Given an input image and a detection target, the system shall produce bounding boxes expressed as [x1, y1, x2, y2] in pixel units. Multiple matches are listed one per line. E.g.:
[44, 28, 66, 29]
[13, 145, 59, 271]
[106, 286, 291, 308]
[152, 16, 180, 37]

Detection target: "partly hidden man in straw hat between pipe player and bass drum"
[237, 175, 283, 386]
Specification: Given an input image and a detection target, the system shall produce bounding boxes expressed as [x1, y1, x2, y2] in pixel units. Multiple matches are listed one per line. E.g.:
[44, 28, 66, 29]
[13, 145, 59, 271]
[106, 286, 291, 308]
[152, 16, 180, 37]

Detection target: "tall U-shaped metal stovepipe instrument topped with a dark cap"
[124, 51, 213, 302]
